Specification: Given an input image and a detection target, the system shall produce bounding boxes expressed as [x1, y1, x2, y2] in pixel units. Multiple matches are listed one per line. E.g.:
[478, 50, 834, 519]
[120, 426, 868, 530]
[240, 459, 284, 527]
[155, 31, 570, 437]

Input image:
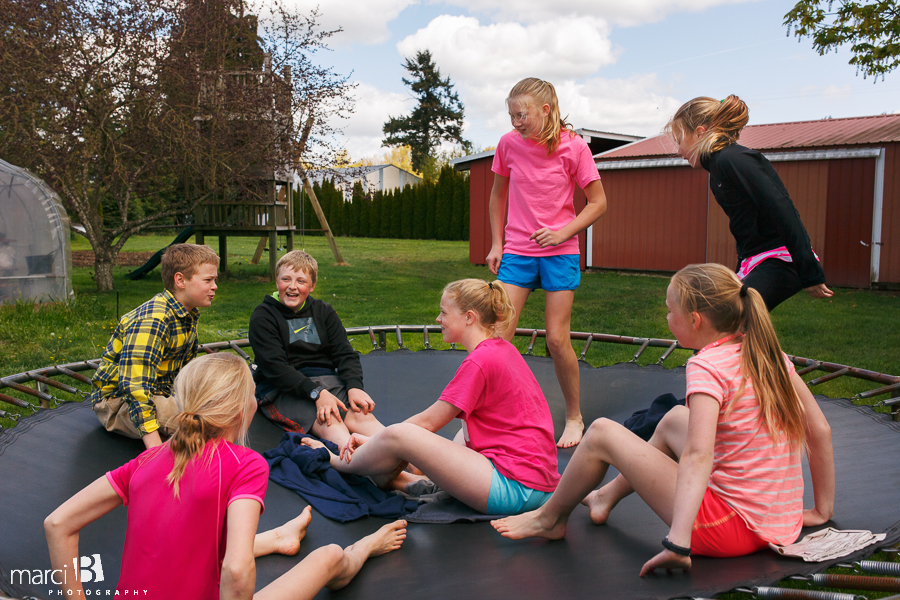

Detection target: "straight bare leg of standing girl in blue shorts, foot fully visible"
[544, 290, 584, 448]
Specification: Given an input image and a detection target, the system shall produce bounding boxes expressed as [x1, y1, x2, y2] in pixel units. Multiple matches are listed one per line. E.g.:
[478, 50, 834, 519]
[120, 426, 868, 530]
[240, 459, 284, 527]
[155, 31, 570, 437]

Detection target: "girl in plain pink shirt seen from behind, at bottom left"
[44, 353, 406, 600]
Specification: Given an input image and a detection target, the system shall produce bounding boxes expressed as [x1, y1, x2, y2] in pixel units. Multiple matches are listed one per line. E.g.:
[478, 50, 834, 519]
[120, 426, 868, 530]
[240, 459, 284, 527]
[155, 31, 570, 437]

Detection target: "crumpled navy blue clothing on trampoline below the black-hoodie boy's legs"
[263, 432, 418, 523]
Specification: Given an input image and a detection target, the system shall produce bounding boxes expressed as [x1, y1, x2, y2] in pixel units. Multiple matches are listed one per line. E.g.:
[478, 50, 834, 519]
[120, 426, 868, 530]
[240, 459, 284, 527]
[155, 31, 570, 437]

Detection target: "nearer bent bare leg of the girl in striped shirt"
[491, 419, 678, 540]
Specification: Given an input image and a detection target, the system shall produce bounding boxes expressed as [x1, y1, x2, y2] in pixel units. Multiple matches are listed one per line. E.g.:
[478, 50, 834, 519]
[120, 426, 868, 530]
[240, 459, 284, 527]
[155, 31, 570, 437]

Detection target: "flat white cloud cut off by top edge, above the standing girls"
[445, 0, 757, 26]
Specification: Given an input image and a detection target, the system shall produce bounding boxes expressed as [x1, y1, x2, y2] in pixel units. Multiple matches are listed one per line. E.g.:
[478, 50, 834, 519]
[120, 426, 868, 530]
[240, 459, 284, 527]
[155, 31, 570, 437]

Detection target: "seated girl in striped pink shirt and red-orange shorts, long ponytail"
[492, 264, 834, 576]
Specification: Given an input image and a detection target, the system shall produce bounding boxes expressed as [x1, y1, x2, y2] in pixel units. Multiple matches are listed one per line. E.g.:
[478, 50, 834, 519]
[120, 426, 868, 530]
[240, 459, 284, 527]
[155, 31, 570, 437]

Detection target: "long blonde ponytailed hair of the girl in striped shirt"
[672, 263, 805, 443]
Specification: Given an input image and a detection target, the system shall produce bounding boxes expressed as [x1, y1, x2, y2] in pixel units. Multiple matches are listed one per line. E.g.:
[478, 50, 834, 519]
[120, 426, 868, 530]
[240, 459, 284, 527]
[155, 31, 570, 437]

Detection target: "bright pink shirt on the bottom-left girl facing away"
[106, 440, 269, 600]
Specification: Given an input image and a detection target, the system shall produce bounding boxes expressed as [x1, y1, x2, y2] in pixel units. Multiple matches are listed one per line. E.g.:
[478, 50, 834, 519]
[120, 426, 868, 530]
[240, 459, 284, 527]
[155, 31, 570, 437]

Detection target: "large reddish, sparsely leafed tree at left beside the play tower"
[0, 0, 352, 290]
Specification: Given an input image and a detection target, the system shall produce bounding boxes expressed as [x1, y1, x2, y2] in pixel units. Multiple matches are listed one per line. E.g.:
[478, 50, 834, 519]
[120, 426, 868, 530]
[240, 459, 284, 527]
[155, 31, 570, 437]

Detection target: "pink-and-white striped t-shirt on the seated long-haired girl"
[687, 344, 803, 544]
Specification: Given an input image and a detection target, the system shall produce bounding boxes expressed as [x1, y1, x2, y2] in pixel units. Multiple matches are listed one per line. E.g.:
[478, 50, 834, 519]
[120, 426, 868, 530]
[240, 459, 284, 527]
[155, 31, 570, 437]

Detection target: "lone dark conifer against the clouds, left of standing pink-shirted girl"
[382, 50, 468, 171]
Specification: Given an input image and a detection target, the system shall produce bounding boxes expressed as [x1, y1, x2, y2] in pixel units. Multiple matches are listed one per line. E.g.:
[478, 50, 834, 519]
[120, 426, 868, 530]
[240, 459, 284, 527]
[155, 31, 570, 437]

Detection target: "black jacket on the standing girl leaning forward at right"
[701, 144, 825, 288]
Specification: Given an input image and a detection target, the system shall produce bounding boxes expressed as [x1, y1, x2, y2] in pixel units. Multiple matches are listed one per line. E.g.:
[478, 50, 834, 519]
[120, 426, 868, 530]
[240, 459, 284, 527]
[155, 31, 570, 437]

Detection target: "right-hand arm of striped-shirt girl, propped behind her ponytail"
[791, 373, 834, 527]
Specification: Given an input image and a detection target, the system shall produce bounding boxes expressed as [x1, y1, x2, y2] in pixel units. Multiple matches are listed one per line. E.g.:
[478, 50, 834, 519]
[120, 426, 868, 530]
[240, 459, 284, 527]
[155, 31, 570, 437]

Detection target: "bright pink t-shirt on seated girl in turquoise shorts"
[440, 339, 559, 492]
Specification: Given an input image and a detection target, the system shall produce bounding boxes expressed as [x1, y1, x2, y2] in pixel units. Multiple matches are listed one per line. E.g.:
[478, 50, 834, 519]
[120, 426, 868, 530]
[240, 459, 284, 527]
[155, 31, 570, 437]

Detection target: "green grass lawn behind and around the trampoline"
[0, 234, 900, 426]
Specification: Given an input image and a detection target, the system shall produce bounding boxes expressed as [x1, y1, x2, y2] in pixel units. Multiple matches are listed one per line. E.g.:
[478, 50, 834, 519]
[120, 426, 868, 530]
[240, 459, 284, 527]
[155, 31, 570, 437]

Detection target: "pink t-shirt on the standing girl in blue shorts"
[491, 131, 600, 256]
